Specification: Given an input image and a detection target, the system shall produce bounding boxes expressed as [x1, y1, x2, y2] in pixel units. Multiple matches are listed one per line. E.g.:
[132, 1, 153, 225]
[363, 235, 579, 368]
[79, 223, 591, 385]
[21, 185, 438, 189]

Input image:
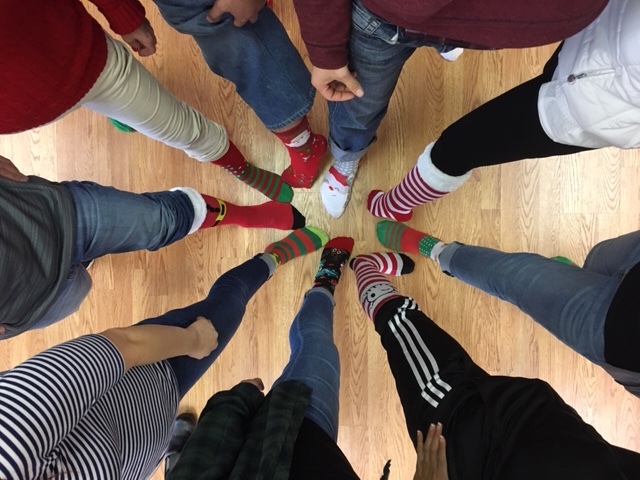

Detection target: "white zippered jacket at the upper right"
[538, 0, 640, 148]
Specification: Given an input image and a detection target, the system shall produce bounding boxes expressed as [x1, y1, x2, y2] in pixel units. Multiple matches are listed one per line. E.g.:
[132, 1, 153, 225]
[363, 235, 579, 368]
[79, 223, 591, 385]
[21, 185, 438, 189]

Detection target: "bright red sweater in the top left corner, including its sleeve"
[0, 0, 145, 134]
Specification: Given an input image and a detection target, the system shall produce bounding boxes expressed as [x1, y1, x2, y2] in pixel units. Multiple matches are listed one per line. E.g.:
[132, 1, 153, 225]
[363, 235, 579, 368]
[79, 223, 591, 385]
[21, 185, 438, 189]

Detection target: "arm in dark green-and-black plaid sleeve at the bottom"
[168, 379, 264, 480]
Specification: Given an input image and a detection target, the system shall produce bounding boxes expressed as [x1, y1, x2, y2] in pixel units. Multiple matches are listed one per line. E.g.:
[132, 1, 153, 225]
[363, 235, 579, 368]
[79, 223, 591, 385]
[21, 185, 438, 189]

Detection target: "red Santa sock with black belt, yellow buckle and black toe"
[199, 193, 305, 230]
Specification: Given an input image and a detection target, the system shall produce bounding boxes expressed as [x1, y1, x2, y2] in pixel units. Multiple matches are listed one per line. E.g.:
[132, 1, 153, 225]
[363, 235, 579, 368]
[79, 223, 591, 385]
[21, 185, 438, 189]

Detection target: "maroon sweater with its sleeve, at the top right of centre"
[294, 0, 608, 69]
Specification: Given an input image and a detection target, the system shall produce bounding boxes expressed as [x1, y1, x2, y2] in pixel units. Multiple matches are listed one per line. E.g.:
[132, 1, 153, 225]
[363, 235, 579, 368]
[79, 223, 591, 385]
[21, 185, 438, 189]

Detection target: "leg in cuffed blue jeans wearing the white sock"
[320, 4, 415, 217]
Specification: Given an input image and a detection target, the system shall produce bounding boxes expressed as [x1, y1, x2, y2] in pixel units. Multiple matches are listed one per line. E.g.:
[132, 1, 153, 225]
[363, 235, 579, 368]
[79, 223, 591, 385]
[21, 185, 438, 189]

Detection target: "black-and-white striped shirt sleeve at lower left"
[0, 335, 124, 479]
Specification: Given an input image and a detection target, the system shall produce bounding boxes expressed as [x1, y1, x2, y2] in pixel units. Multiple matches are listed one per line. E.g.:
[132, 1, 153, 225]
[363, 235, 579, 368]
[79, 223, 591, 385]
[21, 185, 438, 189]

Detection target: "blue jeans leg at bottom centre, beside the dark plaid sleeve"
[274, 287, 340, 441]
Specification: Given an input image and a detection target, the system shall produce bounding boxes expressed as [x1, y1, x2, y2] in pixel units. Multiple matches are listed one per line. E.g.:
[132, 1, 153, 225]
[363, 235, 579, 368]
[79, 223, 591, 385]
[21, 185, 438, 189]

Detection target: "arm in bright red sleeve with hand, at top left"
[91, 0, 157, 57]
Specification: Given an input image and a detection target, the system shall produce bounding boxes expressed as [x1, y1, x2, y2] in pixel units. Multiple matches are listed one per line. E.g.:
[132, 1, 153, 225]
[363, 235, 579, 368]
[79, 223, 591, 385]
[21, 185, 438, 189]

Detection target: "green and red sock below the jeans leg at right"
[376, 220, 447, 260]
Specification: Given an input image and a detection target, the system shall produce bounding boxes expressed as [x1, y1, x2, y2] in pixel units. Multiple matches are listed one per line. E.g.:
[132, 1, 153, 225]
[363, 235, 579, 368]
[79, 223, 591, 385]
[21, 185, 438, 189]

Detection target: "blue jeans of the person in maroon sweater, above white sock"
[329, 0, 451, 162]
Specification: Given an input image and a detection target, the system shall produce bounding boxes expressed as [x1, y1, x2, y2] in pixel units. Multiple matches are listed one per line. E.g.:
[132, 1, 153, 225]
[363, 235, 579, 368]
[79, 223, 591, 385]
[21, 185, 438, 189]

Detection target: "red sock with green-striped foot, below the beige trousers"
[211, 141, 293, 202]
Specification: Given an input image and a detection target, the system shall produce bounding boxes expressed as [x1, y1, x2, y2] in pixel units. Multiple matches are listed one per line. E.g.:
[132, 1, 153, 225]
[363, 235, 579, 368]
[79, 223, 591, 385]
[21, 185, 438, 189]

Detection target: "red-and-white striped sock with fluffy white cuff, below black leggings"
[367, 143, 470, 222]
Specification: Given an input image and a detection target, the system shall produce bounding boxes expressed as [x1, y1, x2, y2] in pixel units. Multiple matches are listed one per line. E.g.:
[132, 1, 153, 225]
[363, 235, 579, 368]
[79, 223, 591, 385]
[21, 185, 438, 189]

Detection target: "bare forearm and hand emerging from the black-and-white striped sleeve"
[101, 317, 218, 371]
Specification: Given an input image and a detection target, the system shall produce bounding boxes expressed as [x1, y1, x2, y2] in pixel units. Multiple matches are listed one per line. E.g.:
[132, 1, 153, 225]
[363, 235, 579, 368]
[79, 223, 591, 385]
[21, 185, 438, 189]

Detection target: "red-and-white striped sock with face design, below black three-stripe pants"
[349, 253, 415, 321]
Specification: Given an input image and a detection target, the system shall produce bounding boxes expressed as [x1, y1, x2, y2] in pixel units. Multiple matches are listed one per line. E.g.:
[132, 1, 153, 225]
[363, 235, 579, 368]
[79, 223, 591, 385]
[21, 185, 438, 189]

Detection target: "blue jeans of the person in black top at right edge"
[439, 232, 640, 363]
